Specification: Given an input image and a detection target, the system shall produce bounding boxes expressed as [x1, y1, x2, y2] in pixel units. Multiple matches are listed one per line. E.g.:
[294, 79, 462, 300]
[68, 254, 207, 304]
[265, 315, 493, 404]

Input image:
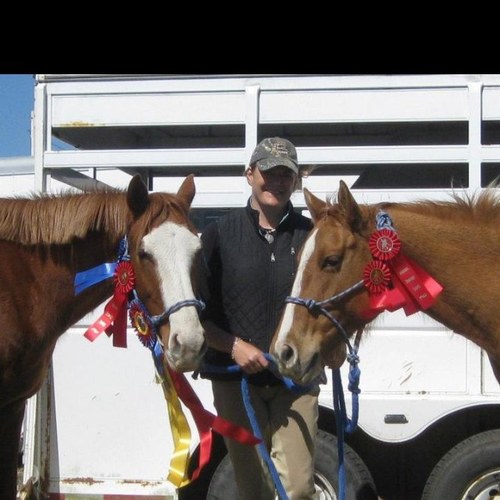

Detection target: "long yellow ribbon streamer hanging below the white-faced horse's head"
[160, 370, 191, 488]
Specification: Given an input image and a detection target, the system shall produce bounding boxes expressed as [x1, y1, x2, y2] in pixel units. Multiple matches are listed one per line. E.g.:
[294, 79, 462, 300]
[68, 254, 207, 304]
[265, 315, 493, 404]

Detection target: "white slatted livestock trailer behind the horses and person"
[17, 75, 500, 500]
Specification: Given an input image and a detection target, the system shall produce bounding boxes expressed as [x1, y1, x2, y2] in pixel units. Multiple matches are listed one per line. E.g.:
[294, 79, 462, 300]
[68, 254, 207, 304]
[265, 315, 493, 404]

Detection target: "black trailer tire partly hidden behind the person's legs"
[207, 431, 378, 500]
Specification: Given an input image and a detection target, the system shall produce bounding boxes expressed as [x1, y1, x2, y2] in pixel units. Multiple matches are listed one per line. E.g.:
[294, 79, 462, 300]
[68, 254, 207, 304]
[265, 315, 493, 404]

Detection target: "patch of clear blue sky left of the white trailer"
[0, 74, 35, 158]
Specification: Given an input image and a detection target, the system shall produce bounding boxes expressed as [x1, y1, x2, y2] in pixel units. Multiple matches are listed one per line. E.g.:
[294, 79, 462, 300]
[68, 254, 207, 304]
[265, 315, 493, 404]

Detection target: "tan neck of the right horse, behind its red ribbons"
[386, 204, 500, 359]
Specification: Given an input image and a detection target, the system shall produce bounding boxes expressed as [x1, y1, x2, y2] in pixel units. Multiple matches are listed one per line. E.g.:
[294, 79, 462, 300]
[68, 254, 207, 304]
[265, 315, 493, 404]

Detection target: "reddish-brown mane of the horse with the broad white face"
[0, 188, 128, 245]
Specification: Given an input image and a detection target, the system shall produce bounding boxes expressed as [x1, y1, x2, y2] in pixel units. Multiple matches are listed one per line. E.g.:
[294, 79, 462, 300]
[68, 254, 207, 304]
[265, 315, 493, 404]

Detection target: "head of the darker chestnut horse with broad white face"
[127, 175, 206, 371]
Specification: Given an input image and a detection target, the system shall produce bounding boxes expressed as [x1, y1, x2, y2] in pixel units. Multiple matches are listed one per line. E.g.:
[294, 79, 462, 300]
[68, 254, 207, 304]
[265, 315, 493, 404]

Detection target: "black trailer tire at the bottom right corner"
[422, 430, 500, 500]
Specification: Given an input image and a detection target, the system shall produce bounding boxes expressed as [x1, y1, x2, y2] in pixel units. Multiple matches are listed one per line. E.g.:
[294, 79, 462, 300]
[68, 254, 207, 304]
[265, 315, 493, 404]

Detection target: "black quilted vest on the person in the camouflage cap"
[202, 203, 312, 384]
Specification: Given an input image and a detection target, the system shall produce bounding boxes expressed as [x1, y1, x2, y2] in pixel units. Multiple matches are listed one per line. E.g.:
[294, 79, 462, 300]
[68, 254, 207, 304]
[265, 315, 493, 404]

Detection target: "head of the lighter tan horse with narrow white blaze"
[271, 181, 371, 384]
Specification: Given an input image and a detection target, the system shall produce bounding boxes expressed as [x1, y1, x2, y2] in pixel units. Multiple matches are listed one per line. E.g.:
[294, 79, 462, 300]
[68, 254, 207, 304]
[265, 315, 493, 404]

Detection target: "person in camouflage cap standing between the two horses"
[202, 137, 319, 500]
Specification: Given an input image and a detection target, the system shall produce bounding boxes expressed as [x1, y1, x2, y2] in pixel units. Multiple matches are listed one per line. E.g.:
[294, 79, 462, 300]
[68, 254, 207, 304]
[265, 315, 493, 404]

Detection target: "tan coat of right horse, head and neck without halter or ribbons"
[272, 182, 500, 382]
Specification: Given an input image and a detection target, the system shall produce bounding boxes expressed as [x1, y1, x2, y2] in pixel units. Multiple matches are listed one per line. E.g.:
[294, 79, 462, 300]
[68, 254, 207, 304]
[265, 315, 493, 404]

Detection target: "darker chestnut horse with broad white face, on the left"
[0, 175, 206, 500]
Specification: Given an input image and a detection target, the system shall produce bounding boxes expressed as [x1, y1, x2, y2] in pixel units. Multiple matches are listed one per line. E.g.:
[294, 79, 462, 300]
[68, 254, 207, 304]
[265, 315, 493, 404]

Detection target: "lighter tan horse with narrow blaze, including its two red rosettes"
[271, 181, 500, 383]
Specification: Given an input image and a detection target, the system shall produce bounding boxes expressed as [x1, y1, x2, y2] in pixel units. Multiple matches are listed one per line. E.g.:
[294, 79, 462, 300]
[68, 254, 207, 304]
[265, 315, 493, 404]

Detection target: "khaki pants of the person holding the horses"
[212, 381, 319, 500]
